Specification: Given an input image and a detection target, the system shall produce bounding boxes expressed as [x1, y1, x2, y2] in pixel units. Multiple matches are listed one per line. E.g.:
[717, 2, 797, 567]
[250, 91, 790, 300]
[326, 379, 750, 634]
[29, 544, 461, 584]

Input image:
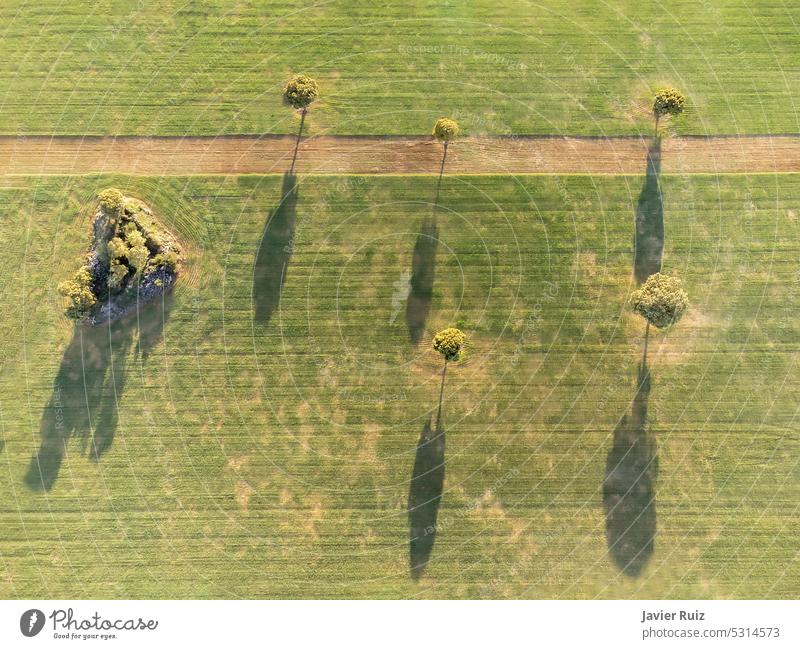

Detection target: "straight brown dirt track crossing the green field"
[0, 135, 800, 176]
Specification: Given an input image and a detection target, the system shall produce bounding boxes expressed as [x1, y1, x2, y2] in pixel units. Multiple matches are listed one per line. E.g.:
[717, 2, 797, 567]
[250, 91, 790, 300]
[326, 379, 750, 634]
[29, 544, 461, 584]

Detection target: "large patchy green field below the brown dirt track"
[0, 170, 800, 598]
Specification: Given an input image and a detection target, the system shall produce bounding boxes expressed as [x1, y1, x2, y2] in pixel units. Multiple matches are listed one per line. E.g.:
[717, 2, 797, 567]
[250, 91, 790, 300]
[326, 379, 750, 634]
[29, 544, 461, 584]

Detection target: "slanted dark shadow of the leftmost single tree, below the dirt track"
[253, 173, 298, 324]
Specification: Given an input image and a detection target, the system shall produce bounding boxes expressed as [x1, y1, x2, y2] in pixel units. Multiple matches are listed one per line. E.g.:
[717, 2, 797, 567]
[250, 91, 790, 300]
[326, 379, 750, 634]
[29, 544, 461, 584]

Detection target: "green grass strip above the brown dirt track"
[0, 0, 800, 135]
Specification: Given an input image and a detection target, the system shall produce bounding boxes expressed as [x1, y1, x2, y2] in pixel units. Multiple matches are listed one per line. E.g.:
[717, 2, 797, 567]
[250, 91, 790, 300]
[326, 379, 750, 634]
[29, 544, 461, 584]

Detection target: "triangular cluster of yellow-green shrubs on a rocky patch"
[58, 189, 180, 320]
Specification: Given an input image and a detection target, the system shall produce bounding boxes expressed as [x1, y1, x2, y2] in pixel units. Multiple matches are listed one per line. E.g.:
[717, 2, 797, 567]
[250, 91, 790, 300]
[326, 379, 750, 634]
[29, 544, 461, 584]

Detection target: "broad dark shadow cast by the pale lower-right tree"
[603, 363, 658, 577]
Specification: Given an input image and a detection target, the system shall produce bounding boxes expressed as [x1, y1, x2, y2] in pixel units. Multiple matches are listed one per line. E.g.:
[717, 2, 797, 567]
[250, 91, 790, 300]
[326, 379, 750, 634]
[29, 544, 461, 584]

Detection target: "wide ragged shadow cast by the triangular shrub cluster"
[25, 291, 174, 491]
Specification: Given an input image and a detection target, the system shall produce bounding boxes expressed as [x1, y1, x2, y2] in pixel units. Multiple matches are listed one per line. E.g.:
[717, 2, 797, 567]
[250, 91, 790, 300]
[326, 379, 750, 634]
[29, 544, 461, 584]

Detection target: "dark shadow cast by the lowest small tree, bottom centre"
[408, 417, 445, 581]
